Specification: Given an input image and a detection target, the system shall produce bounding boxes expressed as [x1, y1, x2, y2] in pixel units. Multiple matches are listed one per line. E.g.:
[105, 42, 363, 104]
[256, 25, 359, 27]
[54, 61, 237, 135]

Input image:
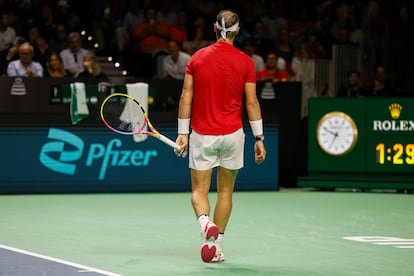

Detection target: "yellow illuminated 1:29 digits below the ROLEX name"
[375, 143, 414, 165]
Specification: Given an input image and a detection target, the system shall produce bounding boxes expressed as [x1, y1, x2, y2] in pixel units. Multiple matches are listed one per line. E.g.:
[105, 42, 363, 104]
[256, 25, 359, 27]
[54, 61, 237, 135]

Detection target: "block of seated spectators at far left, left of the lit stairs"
[0, 1, 107, 81]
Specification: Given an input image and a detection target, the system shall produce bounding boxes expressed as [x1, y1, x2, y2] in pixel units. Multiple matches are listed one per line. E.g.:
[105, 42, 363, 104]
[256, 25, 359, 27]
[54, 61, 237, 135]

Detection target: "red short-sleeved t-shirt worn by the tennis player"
[186, 42, 256, 135]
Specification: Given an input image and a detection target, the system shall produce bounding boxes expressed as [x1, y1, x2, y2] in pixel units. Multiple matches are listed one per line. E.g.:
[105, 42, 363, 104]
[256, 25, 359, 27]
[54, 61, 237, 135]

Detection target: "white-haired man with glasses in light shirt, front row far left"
[7, 42, 43, 77]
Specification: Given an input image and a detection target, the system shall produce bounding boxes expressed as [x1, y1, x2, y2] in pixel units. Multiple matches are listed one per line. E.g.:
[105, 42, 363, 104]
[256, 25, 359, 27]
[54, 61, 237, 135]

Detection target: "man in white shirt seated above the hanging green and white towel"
[60, 32, 88, 77]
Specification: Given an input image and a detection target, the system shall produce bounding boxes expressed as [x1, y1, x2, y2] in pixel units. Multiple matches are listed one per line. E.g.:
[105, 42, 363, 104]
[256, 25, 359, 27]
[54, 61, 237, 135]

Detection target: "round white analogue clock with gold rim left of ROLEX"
[316, 112, 358, 156]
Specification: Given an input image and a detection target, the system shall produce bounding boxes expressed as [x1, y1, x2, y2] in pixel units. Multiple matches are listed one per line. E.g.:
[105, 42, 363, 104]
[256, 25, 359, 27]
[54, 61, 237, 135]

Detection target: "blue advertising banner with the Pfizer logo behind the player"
[0, 128, 279, 193]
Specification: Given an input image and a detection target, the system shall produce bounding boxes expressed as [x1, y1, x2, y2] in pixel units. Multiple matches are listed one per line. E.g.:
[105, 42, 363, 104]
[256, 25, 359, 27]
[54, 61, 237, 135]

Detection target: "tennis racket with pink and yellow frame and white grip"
[101, 93, 182, 155]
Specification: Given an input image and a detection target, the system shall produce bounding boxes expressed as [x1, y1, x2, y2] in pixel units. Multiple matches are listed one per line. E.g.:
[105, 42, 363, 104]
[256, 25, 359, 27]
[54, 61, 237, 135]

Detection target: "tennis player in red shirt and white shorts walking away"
[176, 10, 266, 262]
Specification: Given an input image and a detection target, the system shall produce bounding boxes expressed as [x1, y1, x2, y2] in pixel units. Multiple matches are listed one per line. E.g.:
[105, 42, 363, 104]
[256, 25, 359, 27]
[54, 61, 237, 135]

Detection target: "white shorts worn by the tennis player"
[189, 128, 245, 170]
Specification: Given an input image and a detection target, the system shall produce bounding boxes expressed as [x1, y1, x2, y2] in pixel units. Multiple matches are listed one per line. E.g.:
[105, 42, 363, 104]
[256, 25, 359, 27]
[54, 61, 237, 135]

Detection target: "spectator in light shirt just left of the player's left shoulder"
[162, 40, 191, 80]
